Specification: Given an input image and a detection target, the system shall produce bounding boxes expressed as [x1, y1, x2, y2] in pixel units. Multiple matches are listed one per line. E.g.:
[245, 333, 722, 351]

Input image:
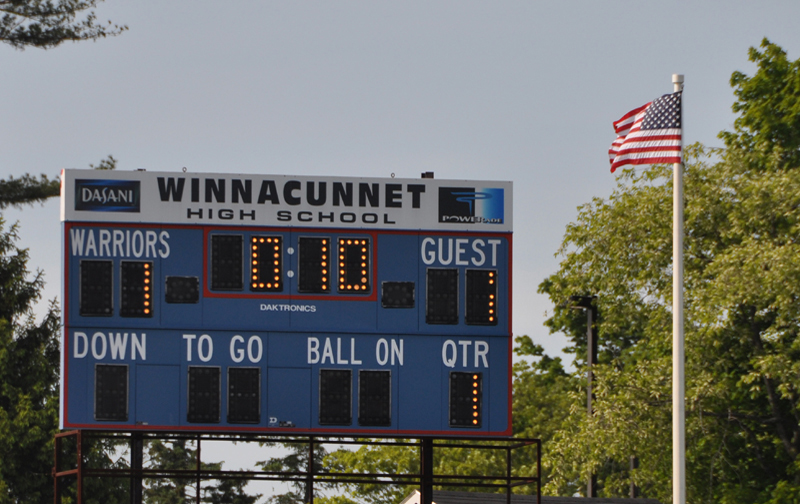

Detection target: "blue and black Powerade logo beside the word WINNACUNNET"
[439, 187, 505, 224]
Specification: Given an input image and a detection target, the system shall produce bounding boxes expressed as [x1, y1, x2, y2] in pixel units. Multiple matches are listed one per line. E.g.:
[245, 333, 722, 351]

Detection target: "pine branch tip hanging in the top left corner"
[0, 0, 128, 49]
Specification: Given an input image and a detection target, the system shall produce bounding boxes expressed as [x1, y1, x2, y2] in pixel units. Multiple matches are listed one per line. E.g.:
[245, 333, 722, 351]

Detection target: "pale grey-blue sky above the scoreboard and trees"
[0, 0, 800, 496]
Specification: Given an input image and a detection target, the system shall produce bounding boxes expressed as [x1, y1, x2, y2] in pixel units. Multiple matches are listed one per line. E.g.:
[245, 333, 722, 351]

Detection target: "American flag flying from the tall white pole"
[608, 91, 681, 173]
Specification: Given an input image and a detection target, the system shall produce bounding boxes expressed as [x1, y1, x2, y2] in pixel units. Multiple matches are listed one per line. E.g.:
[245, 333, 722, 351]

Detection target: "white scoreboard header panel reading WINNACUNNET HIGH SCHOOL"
[61, 170, 512, 232]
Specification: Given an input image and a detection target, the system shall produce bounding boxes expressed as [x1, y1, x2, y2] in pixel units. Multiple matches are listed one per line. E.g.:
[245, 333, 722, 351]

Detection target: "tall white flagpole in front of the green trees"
[672, 74, 686, 504]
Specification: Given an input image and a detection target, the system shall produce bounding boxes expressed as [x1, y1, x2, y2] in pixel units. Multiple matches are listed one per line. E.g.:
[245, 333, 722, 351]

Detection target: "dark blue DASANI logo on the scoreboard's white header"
[75, 180, 141, 213]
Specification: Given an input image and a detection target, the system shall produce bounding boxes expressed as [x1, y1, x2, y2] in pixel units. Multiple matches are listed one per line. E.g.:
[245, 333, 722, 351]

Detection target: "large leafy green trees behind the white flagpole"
[540, 40, 800, 504]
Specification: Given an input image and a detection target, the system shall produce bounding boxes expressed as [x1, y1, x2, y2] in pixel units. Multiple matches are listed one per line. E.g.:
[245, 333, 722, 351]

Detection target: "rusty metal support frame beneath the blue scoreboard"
[52, 430, 542, 504]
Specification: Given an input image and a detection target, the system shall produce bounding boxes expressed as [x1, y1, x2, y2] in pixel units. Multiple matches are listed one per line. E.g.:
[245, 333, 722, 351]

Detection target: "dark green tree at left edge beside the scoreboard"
[0, 217, 60, 504]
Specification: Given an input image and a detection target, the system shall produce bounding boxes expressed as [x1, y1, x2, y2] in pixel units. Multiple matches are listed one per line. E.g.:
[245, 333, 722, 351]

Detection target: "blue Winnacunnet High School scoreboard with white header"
[61, 170, 512, 436]
